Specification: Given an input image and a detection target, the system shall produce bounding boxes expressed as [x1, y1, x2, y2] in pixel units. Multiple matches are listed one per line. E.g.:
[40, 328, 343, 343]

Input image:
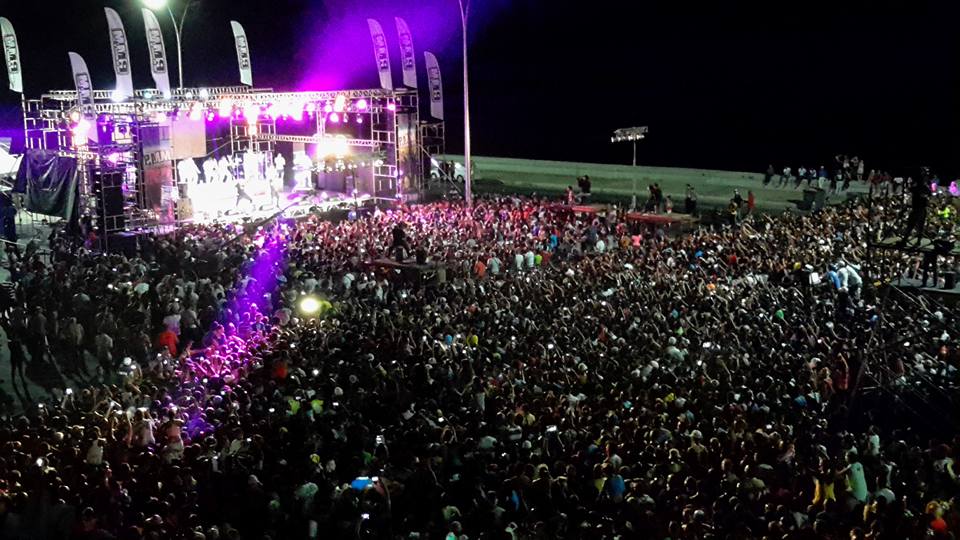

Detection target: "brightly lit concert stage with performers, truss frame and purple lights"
[23, 86, 428, 251]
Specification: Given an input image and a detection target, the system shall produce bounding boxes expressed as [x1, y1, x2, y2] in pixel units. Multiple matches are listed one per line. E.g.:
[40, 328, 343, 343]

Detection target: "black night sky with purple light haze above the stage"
[0, 0, 960, 174]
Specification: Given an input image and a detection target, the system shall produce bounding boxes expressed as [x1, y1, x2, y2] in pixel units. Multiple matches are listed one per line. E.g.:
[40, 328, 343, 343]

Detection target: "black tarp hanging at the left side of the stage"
[13, 148, 80, 221]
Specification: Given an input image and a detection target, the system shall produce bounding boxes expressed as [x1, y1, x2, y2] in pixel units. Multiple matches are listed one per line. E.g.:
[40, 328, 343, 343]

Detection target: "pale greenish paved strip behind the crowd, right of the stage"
[432, 155, 866, 212]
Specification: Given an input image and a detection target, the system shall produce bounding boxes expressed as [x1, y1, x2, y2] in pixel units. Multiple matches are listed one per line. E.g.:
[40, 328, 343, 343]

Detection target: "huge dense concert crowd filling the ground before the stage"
[0, 187, 960, 540]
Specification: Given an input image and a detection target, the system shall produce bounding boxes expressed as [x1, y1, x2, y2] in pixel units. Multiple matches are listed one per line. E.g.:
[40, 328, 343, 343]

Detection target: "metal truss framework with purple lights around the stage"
[23, 86, 444, 249]
